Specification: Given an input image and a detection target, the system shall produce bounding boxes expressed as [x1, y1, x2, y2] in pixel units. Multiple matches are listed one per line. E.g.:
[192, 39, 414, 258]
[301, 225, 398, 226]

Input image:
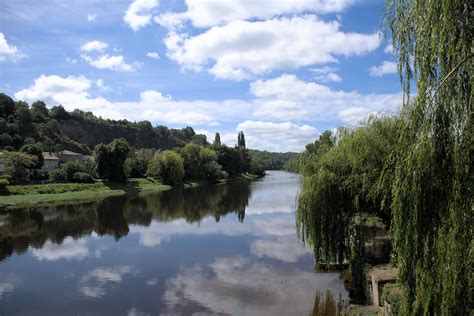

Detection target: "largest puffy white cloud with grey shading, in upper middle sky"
[165, 15, 380, 80]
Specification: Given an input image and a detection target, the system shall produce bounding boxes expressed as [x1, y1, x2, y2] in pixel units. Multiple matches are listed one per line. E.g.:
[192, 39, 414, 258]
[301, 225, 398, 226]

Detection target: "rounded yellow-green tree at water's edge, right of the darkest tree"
[147, 150, 184, 185]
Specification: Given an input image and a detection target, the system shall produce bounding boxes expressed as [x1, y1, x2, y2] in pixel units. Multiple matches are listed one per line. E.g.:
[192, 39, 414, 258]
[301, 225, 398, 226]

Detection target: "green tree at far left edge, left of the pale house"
[2, 151, 38, 184]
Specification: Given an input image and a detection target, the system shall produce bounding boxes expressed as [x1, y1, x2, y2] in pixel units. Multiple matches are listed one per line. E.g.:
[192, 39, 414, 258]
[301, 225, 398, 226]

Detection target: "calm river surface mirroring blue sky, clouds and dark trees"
[0, 171, 347, 315]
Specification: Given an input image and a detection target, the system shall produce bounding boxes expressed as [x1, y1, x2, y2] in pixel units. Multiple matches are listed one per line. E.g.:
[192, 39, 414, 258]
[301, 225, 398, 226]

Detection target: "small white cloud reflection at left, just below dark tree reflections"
[32, 237, 89, 261]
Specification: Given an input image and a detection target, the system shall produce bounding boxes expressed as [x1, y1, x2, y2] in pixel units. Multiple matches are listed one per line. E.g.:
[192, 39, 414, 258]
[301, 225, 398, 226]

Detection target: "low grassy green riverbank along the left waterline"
[0, 174, 258, 209]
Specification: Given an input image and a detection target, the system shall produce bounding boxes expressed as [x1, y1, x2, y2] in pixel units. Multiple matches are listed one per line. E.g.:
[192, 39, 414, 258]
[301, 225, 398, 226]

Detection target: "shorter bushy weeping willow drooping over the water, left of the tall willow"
[296, 116, 400, 267]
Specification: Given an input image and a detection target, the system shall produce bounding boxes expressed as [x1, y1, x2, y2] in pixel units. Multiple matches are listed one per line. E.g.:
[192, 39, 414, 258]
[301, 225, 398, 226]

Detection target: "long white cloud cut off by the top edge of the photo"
[155, 0, 355, 28]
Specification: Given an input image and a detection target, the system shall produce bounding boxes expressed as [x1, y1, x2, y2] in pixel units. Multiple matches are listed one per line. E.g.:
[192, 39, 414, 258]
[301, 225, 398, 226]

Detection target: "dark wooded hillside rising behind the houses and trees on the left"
[0, 93, 205, 154]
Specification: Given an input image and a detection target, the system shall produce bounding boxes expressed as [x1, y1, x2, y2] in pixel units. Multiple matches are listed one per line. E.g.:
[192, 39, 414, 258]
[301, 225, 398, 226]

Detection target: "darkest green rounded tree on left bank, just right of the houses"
[94, 139, 130, 182]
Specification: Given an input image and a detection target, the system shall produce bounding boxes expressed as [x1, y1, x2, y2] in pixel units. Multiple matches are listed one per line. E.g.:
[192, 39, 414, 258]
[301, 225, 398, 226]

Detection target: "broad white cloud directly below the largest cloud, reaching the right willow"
[250, 74, 402, 124]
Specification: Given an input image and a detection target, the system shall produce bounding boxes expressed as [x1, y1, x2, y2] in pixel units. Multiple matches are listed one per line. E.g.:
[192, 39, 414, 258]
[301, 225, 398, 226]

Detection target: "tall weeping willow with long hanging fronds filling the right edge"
[385, 0, 474, 315]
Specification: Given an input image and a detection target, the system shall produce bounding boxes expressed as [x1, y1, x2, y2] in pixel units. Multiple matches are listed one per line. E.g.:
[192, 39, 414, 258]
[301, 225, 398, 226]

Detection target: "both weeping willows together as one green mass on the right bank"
[293, 0, 474, 315]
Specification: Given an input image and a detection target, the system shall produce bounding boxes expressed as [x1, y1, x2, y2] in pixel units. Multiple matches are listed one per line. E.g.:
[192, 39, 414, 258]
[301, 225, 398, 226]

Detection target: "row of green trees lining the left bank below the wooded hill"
[1, 132, 264, 185]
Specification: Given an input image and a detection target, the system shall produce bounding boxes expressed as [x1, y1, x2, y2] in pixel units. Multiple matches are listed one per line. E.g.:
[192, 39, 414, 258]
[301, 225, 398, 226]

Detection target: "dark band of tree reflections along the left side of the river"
[0, 182, 250, 260]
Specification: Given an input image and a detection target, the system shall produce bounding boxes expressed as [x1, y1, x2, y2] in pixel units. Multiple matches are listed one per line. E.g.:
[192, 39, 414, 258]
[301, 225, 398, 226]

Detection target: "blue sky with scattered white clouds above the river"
[0, 0, 402, 151]
